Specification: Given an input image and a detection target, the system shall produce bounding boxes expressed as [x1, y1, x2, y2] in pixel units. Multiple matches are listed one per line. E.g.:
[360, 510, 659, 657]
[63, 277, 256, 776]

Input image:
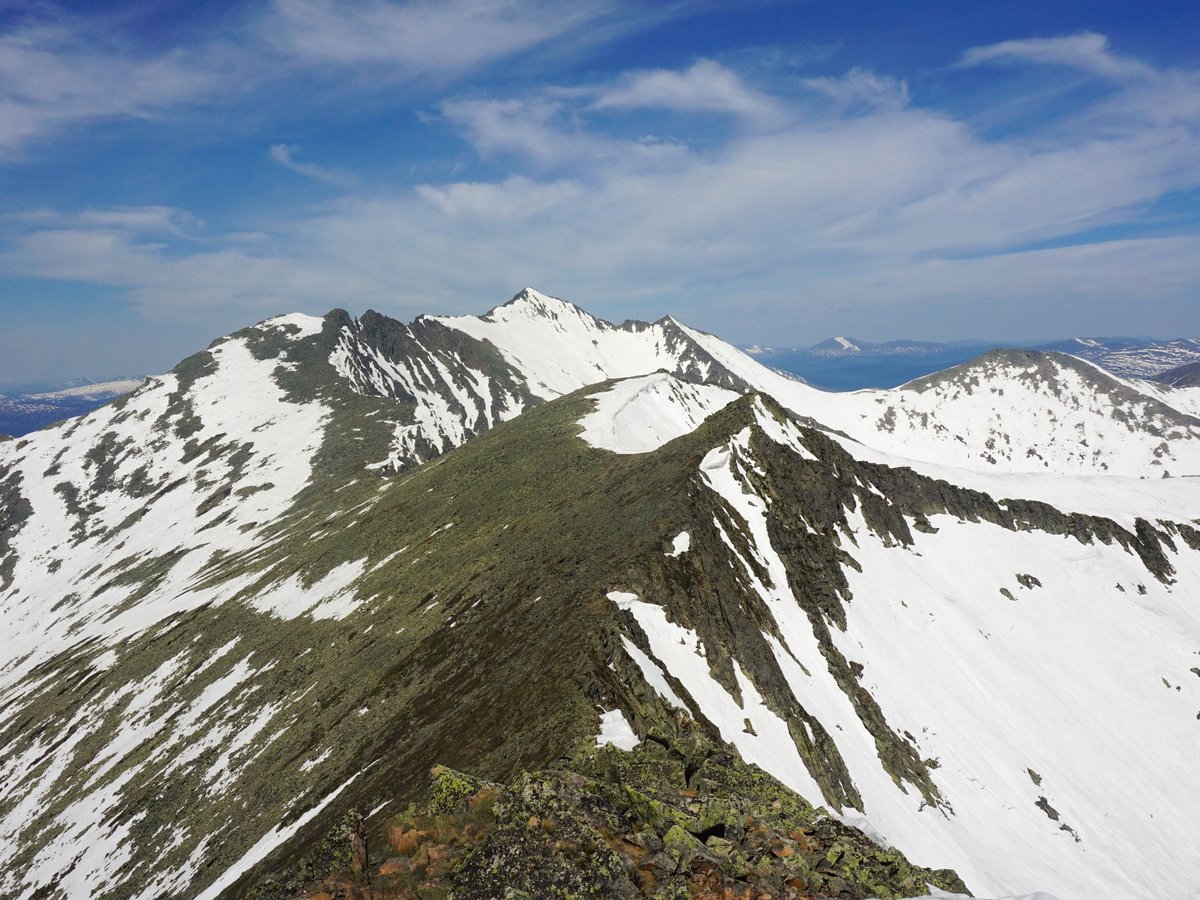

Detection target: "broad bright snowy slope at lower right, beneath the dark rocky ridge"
[592, 404, 1200, 900]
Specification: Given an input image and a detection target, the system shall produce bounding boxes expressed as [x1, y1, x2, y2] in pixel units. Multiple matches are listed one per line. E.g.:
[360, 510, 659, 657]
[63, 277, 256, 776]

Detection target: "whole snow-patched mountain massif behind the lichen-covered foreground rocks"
[0, 290, 1200, 900]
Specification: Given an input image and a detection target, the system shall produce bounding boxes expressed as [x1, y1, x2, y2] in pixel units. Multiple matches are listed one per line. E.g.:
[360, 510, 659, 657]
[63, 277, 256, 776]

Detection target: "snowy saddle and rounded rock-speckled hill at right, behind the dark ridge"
[672, 329, 1200, 478]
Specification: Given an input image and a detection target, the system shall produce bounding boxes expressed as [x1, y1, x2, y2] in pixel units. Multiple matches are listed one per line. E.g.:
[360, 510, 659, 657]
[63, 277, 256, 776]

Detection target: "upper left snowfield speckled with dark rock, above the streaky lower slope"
[0, 338, 326, 678]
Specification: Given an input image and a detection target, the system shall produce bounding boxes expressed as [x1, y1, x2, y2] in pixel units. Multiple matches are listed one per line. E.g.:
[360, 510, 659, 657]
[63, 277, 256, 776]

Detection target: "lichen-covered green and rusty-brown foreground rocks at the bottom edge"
[278, 726, 966, 900]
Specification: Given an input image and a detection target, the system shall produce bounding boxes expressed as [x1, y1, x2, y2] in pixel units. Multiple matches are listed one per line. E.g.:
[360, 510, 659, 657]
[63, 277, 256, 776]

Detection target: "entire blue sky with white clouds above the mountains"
[0, 0, 1200, 380]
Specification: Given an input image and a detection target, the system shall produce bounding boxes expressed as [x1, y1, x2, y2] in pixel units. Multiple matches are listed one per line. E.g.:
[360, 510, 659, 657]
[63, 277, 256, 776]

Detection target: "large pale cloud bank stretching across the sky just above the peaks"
[0, 36, 1200, 340]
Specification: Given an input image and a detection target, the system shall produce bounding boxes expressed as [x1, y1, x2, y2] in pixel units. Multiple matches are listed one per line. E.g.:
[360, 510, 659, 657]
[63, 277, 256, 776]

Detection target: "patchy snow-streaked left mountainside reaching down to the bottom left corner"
[0, 319, 364, 896]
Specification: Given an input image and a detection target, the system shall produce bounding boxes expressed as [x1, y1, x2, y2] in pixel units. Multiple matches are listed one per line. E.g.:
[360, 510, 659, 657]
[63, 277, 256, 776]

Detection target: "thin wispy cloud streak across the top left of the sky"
[0, 0, 670, 160]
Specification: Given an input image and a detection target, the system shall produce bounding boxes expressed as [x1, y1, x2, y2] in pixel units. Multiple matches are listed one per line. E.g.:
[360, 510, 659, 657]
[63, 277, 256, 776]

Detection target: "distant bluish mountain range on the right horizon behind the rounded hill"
[746, 337, 1200, 390]
